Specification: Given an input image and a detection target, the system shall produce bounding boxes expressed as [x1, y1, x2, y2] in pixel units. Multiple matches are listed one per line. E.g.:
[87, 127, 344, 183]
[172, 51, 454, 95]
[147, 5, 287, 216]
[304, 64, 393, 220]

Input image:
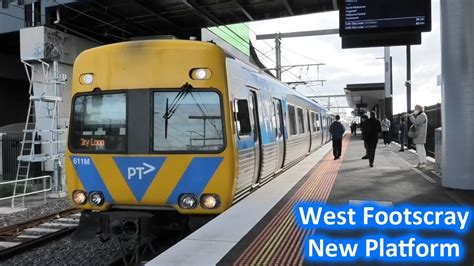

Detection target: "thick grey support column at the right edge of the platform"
[440, 0, 474, 190]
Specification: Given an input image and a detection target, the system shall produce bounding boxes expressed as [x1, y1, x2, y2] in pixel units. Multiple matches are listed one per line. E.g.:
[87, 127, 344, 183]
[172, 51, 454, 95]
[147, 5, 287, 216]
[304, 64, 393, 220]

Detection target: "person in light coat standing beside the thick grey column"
[408, 104, 428, 168]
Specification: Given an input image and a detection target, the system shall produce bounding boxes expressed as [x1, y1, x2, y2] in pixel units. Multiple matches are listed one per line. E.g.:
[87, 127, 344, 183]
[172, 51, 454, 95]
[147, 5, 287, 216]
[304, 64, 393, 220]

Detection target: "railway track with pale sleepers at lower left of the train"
[0, 209, 81, 260]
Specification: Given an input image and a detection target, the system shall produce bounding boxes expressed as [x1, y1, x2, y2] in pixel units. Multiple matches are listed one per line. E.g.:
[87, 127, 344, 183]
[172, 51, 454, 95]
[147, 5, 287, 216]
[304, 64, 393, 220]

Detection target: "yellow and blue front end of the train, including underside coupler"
[66, 40, 236, 238]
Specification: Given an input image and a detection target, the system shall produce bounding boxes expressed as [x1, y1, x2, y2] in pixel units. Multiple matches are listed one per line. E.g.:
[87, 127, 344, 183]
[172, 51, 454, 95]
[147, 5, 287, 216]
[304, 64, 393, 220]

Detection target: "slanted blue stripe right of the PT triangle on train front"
[167, 157, 223, 204]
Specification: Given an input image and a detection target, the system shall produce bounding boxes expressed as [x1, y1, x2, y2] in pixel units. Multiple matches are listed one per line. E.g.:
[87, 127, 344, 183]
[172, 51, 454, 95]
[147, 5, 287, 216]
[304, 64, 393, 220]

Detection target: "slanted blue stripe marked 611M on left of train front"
[69, 156, 113, 202]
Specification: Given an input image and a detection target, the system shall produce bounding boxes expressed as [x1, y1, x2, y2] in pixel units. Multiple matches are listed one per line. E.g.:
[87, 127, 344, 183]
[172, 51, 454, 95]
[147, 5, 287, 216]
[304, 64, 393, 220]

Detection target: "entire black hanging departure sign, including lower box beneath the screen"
[339, 0, 431, 48]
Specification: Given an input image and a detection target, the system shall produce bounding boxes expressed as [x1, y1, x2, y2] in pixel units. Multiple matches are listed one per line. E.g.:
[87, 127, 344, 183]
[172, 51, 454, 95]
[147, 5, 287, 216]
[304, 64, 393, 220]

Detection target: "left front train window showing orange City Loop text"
[69, 93, 127, 153]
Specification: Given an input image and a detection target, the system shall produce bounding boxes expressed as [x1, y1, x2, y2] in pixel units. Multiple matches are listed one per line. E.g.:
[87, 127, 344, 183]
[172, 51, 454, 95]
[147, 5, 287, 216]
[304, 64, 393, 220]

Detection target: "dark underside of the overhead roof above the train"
[46, 0, 337, 43]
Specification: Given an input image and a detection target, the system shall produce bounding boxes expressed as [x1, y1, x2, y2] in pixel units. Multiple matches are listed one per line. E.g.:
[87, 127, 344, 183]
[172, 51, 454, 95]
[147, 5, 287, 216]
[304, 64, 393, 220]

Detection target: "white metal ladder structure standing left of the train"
[11, 59, 67, 207]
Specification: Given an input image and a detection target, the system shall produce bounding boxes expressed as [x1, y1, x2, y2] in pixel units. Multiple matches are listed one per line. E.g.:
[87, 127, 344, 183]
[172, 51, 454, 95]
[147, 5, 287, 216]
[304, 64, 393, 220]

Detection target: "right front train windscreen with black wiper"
[153, 91, 224, 152]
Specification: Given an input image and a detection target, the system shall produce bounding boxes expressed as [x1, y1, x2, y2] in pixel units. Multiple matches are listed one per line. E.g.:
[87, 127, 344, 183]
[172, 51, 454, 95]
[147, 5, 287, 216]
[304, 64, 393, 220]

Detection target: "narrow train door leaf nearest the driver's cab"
[249, 90, 262, 186]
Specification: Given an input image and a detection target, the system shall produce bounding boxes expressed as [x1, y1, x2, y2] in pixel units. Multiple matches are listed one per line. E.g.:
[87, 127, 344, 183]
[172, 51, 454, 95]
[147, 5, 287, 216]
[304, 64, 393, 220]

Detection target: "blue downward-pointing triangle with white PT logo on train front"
[114, 157, 166, 201]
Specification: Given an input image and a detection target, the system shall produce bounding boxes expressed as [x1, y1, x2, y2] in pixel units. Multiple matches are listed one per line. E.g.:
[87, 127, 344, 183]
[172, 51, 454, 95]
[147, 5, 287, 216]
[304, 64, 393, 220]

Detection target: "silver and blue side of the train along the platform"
[226, 58, 327, 199]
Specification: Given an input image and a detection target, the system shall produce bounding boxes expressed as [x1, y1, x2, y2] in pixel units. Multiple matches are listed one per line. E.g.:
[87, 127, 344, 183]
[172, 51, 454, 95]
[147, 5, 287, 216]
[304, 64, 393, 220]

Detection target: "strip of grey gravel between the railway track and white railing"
[0, 199, 72, 227]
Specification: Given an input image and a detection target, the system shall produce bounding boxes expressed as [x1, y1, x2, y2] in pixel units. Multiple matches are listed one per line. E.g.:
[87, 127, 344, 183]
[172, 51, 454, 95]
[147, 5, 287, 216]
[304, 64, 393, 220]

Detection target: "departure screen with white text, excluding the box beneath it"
[339, 0, 431, 36]
